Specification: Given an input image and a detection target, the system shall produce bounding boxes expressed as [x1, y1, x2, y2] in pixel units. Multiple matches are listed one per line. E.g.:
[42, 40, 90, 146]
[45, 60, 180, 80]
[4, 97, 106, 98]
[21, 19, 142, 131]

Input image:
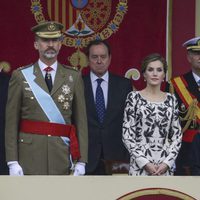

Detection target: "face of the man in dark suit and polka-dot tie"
[89, 44, 111, 77]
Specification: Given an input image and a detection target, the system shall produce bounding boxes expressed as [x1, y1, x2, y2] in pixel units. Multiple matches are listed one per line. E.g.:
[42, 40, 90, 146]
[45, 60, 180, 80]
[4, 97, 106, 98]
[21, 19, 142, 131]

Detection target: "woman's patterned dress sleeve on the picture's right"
[163, 95, 182, 168]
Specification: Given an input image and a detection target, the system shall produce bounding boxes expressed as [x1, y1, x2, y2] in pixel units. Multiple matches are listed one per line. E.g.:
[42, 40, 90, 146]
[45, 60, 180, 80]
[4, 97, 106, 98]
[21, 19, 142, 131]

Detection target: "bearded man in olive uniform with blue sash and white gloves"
[5, 21, 88, 176]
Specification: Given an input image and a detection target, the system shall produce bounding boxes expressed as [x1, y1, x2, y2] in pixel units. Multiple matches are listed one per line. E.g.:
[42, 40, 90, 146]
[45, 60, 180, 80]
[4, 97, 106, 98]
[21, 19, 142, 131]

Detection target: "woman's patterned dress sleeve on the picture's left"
[122, 91, 149, 168]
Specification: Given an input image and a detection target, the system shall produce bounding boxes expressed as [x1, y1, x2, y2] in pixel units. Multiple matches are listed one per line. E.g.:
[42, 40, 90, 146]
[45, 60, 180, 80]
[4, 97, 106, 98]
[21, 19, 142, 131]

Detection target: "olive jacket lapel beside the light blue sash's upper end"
[33, 63, 49, 93]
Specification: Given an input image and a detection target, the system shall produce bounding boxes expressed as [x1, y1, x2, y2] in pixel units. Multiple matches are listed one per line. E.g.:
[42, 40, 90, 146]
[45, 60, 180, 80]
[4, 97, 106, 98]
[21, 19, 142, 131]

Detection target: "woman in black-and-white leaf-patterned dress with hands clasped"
[123, 54, 182, 176]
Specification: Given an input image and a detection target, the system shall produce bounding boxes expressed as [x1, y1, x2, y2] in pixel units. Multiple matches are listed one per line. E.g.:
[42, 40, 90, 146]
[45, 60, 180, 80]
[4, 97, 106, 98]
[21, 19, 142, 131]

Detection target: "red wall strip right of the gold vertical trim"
[172, 0, 195, 76]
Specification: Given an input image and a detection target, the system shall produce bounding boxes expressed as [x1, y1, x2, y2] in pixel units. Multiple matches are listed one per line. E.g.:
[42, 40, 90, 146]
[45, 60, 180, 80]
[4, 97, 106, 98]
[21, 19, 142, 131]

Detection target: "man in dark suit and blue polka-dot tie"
[83, 40, 132, 175]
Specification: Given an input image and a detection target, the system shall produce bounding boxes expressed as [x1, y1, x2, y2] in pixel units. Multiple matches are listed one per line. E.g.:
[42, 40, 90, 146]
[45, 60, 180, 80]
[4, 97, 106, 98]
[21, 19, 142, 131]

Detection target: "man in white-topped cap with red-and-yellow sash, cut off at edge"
[171, 37, 200, 175]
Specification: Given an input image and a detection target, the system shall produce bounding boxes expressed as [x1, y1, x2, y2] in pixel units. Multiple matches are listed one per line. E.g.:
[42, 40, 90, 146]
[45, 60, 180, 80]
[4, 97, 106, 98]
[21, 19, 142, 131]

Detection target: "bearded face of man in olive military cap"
[34, 38, 61, 60]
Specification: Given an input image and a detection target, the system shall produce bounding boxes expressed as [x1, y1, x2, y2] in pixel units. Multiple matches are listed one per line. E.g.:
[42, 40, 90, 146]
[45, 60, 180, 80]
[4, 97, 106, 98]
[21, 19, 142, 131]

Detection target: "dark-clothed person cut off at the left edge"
[0, 70, 10, 175]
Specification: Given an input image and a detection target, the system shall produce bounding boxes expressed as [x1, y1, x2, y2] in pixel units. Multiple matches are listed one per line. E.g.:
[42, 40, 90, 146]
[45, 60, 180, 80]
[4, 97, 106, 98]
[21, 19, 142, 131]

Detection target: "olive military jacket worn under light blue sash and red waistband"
[6, 63, 88, 175]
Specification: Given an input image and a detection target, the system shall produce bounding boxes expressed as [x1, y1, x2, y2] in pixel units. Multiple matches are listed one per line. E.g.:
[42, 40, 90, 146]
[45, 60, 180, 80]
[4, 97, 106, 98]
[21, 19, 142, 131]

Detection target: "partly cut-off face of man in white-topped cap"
[187, 51, 200, 74]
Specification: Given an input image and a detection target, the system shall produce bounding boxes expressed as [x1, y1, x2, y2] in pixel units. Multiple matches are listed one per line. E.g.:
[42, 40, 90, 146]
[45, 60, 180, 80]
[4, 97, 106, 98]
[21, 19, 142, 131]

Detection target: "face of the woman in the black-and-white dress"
[143, 60, 165, 86]
